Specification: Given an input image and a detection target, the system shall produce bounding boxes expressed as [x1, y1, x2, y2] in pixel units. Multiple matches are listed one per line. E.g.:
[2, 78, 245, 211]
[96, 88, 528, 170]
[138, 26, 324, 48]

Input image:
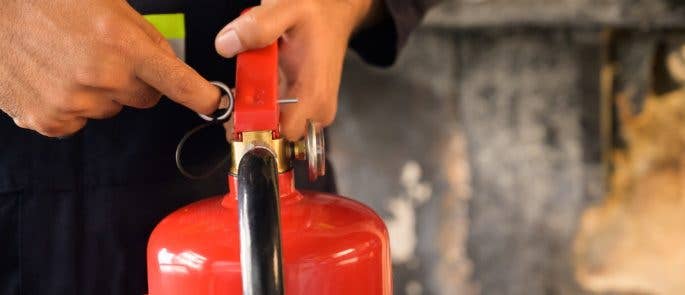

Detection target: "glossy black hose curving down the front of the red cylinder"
[237, 146, 283, 295]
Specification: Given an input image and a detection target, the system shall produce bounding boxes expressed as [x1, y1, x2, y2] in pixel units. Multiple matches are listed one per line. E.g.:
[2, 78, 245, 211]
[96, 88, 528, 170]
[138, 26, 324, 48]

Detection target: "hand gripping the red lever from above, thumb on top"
[215, 0, 375, 140]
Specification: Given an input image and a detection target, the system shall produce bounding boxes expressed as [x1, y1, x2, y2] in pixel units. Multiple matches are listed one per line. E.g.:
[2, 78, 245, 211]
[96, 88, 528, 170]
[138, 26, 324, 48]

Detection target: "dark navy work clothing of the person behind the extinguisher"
[0, 0, 423, 295]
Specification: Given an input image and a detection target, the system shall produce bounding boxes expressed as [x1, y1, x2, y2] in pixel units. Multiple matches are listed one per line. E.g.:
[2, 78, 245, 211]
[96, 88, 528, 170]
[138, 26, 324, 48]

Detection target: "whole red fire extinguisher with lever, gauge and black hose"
[147, 35, 392, 295]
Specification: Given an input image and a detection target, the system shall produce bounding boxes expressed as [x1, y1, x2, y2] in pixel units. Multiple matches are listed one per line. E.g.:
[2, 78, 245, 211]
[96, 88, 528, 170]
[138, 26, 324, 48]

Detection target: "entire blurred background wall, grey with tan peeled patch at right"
[329, 0, 685, 295]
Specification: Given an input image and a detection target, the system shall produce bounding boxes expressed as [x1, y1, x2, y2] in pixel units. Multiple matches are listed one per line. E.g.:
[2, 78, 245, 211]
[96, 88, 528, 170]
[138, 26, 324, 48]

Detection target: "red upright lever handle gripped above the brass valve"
[233, 16, 279, 138]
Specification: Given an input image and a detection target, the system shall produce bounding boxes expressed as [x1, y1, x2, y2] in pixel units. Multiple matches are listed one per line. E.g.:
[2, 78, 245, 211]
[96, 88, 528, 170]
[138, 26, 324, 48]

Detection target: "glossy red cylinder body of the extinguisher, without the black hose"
[148, 172, 392, 295]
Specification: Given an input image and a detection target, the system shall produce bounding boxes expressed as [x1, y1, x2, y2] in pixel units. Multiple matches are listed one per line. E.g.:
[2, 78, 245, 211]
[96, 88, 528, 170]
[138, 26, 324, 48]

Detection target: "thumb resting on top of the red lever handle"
[214, 1, 300, 58]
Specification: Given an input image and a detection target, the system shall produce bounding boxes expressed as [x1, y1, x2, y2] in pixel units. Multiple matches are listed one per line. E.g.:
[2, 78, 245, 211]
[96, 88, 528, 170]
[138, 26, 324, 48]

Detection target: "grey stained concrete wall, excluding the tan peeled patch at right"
[330, 0, 685, 294]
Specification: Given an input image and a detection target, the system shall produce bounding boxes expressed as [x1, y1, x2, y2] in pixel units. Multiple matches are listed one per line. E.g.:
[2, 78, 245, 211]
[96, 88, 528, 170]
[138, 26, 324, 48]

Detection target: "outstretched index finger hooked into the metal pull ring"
[133, 38, 221, 115]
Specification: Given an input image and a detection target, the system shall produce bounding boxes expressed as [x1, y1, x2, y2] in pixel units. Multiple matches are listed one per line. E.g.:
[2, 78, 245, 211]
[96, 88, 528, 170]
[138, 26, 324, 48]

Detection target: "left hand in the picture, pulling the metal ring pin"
[0, 0, 219, 136]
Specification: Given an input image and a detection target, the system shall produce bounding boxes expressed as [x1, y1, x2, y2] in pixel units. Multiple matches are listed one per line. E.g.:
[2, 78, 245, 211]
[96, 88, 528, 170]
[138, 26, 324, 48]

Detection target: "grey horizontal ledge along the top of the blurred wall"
[426, 0, 685, 29]
